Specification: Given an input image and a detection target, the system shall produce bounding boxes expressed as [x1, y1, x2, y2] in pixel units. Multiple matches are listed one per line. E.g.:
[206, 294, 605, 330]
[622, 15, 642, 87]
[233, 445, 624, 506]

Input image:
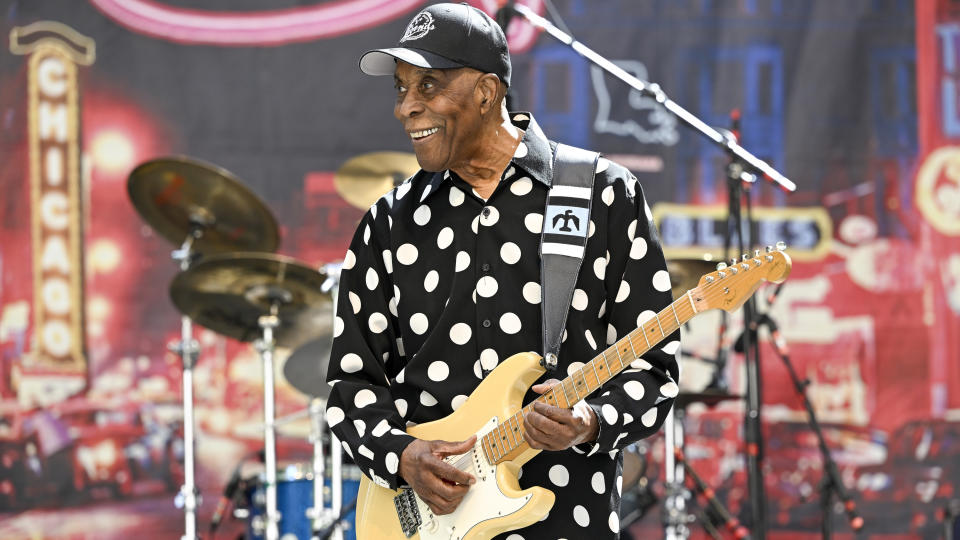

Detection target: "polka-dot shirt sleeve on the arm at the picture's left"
[326, 201, 414, 489]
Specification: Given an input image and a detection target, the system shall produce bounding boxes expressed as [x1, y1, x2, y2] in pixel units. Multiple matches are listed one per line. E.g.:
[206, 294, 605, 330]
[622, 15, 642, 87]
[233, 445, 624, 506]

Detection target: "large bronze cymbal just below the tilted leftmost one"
[170, 253, 333, 348]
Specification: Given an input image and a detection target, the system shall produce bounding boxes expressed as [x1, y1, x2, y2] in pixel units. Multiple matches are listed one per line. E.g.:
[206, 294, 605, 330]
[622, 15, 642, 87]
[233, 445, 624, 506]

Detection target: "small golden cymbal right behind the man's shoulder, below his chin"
[333, 152, 420, 210]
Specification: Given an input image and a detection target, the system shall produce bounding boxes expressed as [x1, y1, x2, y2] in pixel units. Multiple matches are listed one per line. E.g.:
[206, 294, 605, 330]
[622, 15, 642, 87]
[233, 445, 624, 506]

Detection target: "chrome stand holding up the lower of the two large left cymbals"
[255, 298, 290, 540]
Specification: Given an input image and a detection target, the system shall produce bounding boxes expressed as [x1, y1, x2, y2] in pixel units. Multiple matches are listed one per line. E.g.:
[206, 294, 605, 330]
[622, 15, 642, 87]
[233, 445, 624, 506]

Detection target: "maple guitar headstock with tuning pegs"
[691, 242, 793, 312]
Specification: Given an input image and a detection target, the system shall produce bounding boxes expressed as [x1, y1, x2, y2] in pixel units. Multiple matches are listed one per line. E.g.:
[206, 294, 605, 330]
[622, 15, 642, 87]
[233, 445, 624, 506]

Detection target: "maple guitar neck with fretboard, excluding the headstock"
[481, 289, 701, 464]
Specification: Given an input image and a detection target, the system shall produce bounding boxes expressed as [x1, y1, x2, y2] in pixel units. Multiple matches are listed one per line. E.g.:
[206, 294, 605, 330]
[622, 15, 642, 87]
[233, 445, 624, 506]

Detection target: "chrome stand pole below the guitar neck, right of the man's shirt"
[662, 407, 693, 540]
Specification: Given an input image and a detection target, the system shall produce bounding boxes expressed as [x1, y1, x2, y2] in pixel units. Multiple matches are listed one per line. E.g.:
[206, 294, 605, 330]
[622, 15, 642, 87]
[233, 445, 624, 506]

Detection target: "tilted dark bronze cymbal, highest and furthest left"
[127, 156, 280, 253]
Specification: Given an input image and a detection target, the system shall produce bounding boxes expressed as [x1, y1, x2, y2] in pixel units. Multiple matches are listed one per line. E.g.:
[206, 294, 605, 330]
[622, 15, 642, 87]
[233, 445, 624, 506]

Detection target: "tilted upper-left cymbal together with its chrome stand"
[127, 157, 279, 540]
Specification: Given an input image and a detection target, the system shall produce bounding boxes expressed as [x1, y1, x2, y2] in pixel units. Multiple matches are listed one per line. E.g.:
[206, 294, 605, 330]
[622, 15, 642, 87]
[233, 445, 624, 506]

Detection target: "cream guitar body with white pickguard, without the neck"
[357, 353, 554, 540]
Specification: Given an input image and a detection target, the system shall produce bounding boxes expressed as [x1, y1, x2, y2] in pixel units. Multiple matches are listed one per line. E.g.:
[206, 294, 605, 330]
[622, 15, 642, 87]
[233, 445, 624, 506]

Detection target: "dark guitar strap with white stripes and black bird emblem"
[540, 144, 600, 370]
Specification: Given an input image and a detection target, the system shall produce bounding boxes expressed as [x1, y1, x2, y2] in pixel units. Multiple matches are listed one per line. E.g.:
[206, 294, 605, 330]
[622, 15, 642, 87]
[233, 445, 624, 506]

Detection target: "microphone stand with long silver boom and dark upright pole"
[503, 4, 797, 540]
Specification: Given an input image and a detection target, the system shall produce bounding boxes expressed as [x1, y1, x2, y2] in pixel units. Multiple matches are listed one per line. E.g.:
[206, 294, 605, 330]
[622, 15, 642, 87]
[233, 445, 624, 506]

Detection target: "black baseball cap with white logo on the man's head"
[360, 4, 510, 86]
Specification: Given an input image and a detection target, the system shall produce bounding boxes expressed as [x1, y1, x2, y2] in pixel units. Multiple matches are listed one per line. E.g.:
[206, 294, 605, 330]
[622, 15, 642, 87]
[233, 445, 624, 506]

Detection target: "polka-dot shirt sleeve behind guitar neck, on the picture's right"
[578, 170, 680, 454]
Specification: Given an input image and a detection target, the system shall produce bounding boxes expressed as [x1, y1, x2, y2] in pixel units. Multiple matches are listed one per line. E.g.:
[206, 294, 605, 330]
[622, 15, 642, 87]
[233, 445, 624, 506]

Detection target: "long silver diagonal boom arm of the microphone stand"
[510, 4, 797, 191]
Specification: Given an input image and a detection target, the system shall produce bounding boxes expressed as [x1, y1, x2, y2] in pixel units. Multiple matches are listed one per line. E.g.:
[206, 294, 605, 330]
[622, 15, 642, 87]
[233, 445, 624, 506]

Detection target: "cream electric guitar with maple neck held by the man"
[356, 247, 791, 540]
